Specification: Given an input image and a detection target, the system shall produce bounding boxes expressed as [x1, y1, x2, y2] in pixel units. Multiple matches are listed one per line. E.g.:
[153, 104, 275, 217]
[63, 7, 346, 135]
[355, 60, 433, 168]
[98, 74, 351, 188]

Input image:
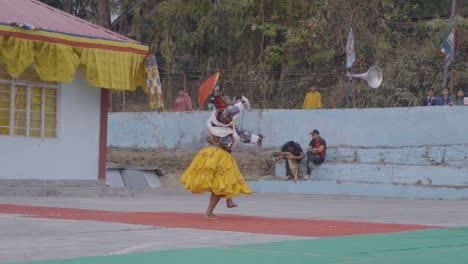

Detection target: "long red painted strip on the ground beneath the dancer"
[0, 204, 440, 237]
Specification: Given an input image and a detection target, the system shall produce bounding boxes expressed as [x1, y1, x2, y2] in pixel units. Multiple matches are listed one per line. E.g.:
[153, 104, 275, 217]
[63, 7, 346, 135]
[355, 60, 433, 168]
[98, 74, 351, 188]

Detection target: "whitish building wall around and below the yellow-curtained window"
[0, 70, 101, 180]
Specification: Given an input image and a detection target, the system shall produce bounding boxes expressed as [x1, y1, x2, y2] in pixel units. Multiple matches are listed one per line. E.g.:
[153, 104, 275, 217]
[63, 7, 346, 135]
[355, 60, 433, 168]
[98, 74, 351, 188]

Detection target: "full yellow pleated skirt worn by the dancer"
[179, 146, 252, 198]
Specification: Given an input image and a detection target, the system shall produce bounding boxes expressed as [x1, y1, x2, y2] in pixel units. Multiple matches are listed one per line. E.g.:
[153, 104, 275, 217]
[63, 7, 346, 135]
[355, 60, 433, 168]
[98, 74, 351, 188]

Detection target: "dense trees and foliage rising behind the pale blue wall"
[42, 0, 468, 108]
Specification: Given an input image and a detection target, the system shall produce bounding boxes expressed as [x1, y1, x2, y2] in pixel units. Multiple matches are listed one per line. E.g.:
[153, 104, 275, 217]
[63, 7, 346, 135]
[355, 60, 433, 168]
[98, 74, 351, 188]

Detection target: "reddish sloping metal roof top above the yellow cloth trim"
[0, 0, 138, 43]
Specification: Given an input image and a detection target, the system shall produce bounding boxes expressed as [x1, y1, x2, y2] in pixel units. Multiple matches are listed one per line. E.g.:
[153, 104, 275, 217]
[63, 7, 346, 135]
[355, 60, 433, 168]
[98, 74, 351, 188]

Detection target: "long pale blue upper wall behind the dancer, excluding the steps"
[108, 106, 468, 148]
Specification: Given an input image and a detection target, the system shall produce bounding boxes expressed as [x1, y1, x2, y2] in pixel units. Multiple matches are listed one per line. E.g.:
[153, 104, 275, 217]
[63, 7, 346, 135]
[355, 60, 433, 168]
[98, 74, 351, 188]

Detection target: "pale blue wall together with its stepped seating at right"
[109, 106, 468, 199]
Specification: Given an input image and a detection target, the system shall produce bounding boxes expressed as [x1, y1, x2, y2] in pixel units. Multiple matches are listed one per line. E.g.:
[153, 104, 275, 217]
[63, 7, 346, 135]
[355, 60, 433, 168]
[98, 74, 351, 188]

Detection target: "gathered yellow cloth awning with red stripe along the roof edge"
[0, 25, 148, 91]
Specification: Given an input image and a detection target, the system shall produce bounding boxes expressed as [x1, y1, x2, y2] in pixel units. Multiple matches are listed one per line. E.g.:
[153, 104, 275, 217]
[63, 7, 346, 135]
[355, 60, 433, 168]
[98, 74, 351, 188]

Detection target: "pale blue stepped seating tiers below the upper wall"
[260, 145, 468, 199]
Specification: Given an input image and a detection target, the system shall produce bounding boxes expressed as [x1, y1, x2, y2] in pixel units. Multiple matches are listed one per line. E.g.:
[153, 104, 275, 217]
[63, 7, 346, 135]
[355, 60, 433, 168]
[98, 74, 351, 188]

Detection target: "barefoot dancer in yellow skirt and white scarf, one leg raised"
[180, 102, 263, 219]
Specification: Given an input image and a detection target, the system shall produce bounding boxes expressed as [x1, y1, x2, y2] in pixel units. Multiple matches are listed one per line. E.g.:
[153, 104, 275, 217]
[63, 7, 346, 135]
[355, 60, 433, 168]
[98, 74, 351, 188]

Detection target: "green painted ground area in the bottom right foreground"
[13, 228, 468, 264]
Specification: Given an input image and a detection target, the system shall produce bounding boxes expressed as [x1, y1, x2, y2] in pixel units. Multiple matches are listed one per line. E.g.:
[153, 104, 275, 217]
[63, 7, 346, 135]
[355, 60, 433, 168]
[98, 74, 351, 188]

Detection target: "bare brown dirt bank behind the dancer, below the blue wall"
[107, 147, 275, 188]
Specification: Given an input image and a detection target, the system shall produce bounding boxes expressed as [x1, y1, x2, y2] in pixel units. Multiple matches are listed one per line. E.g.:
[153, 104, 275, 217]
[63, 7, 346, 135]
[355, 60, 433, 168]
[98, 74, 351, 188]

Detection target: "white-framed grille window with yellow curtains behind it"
[0, 69, 59, 138]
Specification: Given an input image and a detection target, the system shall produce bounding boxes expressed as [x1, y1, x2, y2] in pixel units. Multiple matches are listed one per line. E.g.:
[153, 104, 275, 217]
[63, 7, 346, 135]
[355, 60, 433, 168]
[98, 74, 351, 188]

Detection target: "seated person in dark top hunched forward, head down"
[275, 141, 305, 181]
